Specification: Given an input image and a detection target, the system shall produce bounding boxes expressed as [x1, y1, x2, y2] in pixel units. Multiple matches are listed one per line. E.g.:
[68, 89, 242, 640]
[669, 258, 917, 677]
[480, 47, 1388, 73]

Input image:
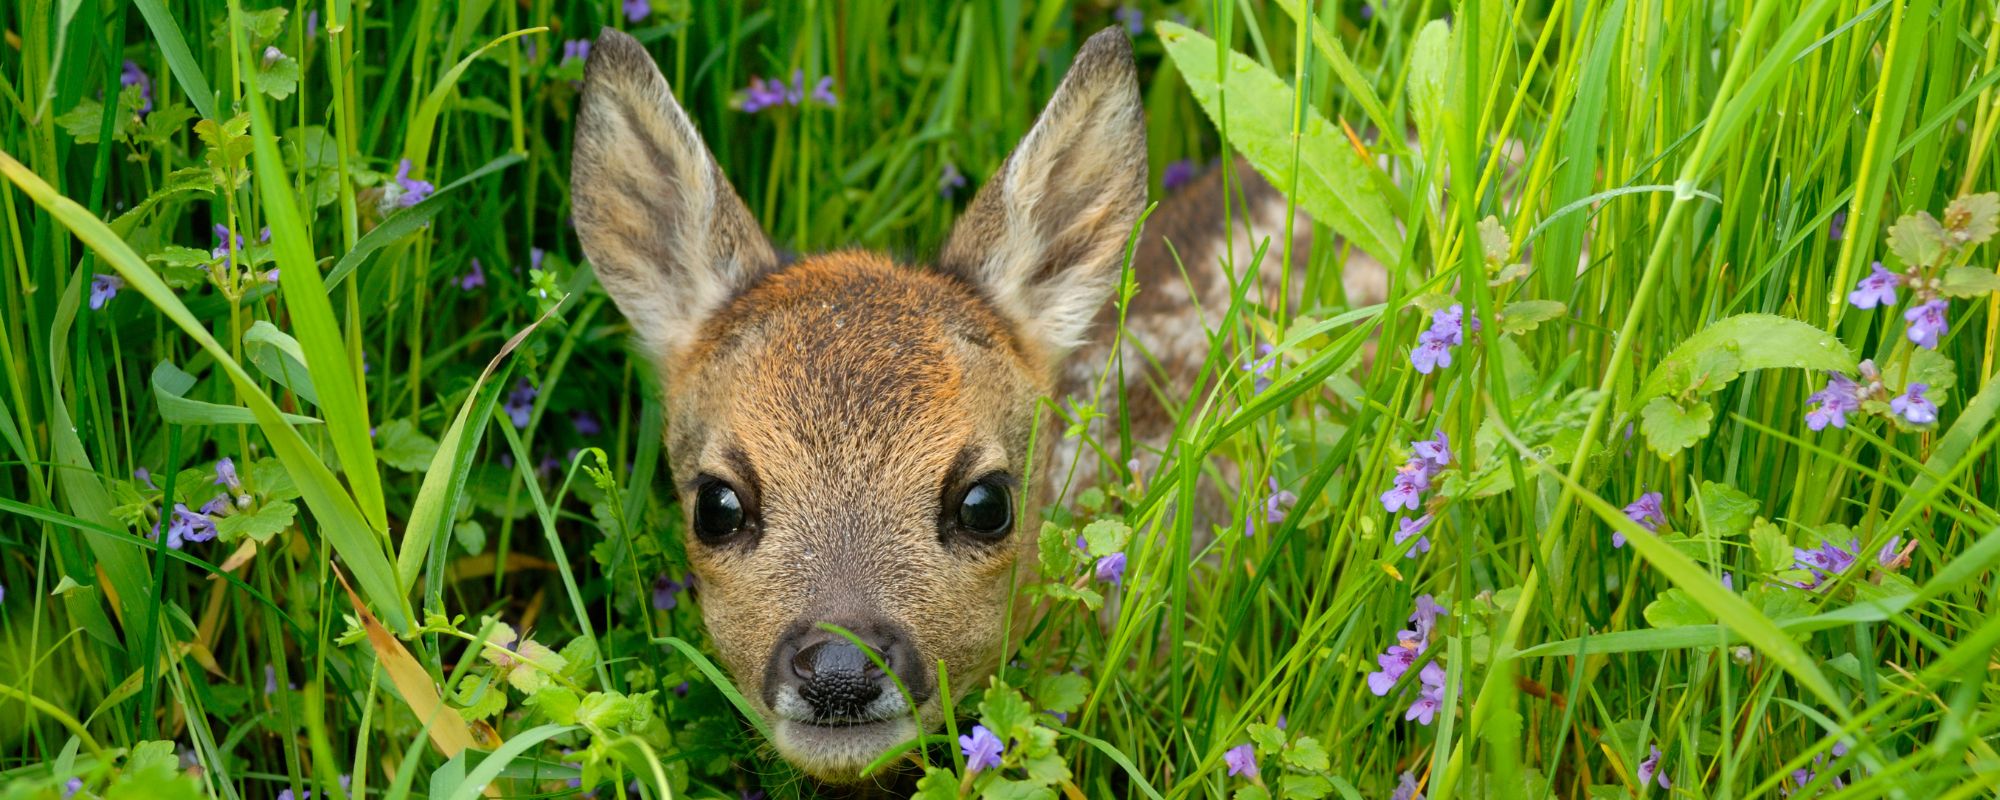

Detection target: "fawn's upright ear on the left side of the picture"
[570, 28, 776, 358]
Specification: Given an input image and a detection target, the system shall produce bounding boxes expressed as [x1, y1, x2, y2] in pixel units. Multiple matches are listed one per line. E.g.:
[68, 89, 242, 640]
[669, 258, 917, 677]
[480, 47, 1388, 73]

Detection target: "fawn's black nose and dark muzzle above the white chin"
[764, 622, 930, 724]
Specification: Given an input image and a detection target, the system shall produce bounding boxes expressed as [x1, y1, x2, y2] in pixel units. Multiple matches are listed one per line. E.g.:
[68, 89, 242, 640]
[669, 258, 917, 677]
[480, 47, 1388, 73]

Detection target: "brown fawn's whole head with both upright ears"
[572, 30, 1146, 782]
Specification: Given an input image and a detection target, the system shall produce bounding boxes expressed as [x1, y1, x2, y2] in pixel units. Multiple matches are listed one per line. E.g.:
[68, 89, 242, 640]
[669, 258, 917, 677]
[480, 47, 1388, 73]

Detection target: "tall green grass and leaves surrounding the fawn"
[0, 0, 2000, 800]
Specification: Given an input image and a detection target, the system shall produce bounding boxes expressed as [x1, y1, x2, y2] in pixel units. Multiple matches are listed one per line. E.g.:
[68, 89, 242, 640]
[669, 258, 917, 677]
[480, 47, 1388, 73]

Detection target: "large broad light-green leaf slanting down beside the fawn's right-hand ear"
[1158, 22, 1402, 264]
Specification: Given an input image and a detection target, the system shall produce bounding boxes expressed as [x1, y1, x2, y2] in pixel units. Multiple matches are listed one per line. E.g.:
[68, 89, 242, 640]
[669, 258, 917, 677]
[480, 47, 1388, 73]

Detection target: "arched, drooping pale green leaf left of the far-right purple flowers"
[1632, 314, 1858, 404]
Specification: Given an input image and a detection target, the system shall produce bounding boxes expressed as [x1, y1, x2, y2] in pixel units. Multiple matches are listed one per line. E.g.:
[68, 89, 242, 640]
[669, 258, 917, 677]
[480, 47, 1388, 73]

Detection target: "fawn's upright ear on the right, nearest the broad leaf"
[938, 28, 1146, 362]
